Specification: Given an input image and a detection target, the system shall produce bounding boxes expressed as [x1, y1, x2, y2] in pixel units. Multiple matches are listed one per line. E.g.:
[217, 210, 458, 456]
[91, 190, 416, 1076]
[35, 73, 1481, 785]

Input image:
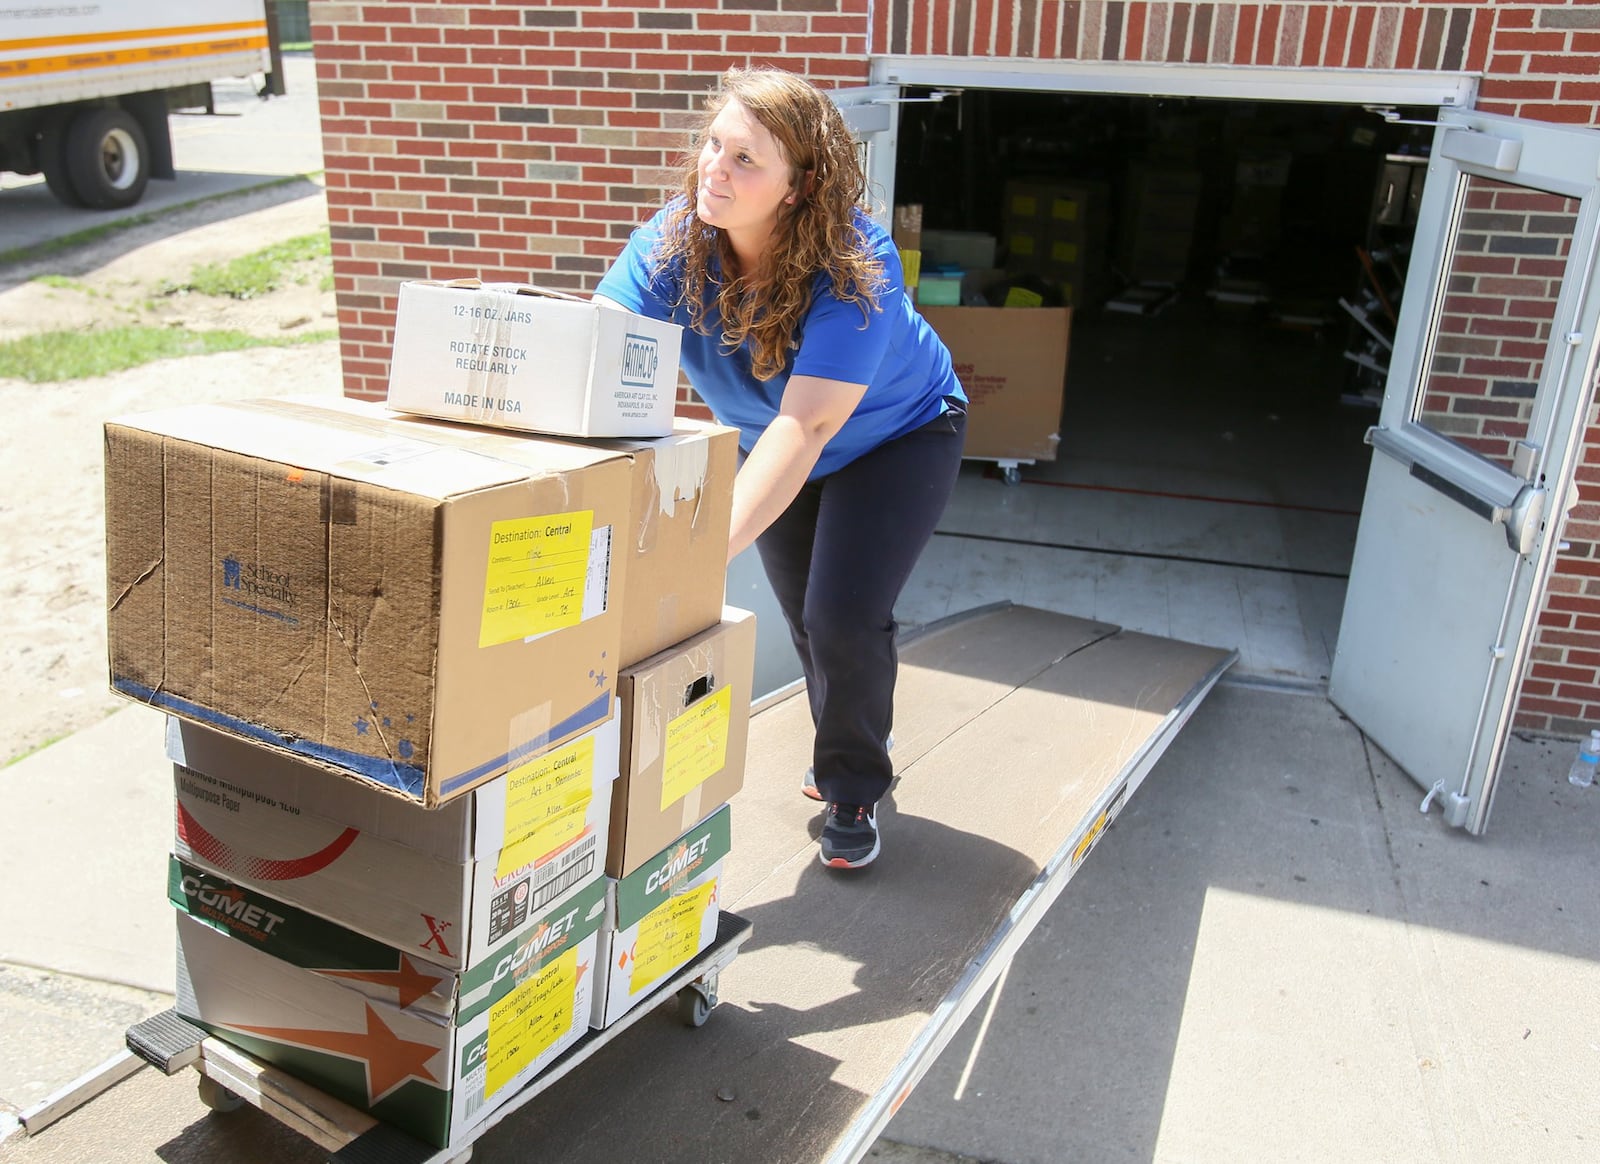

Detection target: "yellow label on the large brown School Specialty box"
[478, 510, 595, 648]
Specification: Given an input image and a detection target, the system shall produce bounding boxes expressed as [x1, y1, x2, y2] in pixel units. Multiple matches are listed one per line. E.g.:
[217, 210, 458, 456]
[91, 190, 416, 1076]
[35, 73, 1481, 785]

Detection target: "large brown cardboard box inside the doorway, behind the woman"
[923, 307, 1072, 460]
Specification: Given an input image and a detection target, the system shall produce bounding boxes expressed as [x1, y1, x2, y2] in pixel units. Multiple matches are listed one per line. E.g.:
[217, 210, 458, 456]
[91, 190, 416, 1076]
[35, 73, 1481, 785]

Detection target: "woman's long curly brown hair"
[654, 67, 885, 381]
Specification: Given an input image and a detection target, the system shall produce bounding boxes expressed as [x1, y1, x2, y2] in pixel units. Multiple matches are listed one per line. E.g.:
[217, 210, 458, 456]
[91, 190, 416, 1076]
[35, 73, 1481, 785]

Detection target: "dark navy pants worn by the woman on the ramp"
[755, 413, 966, 804]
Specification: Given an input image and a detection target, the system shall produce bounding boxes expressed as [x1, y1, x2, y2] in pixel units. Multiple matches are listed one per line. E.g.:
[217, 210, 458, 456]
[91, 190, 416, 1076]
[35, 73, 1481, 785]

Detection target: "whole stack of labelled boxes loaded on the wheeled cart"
[106, 285, 755, 1146]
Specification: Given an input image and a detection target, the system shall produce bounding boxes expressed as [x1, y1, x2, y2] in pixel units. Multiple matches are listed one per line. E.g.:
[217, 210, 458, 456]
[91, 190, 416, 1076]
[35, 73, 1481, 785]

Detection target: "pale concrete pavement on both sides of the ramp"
[0, 681, 1600, 1164]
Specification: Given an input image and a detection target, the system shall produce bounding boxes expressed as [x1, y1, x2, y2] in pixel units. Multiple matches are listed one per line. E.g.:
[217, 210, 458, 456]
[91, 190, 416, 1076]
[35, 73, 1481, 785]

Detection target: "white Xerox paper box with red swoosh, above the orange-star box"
[166, 718, 619, 969]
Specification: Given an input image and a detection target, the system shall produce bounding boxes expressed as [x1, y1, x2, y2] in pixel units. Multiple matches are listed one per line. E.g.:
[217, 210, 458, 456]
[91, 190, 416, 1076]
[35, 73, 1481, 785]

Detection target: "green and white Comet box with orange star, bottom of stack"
[171, 862, 605, 1146]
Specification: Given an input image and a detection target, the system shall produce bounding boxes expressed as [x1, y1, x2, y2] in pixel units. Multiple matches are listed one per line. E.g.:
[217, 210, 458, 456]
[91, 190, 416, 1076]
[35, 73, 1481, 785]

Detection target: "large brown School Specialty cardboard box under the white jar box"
[106, 398, 630, 806]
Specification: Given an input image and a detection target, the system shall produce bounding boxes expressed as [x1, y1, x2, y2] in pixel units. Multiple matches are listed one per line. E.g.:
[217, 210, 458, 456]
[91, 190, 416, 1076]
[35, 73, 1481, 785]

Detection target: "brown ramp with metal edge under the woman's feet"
[502, 606, 1237, 1164]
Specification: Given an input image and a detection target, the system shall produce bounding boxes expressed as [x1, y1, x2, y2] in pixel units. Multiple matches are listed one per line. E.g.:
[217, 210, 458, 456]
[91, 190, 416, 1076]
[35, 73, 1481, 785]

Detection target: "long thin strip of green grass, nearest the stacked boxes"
[0, 325, 336, 384]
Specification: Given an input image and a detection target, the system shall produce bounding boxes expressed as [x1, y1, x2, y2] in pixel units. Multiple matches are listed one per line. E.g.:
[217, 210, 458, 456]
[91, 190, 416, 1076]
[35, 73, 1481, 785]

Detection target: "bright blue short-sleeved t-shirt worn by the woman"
[595, 202, 966, 480]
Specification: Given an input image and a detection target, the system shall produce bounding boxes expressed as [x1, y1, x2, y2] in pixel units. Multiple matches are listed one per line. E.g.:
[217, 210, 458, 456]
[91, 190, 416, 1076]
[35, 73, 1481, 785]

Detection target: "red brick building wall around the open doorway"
[310, 0, 1600, 731]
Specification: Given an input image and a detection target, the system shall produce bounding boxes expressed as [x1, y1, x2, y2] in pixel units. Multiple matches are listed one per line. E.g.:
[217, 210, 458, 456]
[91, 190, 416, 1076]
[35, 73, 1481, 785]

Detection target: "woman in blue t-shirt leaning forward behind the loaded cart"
[595, 69, 966, 868]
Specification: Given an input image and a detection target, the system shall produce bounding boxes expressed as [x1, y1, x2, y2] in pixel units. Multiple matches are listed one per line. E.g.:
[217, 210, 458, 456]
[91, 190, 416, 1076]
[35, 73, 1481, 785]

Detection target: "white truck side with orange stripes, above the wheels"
[0, 0, 272, 110]
